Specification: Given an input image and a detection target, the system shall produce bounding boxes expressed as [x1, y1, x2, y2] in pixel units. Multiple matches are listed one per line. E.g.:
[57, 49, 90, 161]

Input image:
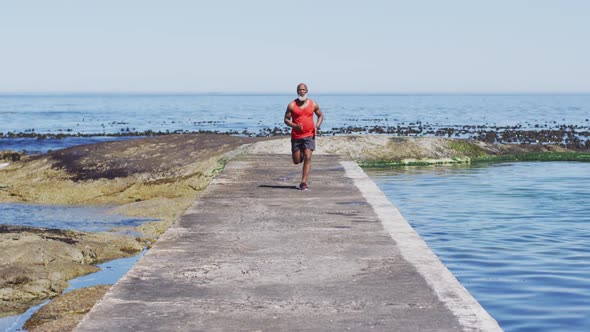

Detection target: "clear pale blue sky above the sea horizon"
[0, 0, 590, 94]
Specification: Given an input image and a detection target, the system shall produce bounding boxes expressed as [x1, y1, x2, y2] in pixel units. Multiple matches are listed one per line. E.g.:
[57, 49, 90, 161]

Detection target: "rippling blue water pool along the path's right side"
[366, 162, 590, 332]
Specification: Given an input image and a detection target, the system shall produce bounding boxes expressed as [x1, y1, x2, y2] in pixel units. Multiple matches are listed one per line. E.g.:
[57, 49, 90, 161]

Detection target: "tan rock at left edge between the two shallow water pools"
[0, 224, 146, 317]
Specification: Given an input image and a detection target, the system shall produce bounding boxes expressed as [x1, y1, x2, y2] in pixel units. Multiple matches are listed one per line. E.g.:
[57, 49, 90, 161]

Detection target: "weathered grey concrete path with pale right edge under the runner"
[77, 155, 500, 331]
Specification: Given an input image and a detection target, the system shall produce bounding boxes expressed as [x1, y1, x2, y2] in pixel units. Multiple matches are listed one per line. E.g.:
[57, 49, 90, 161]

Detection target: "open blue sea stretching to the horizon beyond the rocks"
[0, 94, 590, 152]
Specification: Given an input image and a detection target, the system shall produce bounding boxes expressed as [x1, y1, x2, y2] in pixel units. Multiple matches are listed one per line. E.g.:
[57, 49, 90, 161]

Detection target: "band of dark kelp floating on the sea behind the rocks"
[0, 119, 590, 150]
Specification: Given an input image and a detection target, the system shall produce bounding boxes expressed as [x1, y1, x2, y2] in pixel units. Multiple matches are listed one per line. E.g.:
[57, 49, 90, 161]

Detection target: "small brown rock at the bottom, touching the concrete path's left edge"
[24, 285, 111, 332]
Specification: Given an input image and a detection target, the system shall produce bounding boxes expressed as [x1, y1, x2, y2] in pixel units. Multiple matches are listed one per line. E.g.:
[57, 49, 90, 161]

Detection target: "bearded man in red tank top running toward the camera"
[285, 83, 324, 190]
